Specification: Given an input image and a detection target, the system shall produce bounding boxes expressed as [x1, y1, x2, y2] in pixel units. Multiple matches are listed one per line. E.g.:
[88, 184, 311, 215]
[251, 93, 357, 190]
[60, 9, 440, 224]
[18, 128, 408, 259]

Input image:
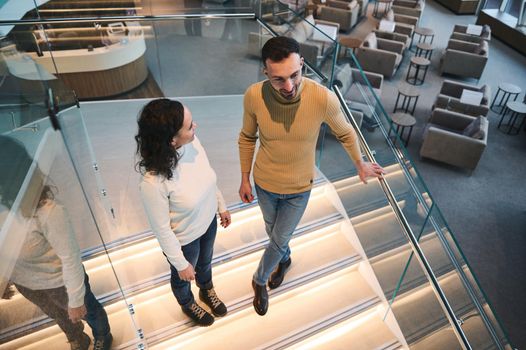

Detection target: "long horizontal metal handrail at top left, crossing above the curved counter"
[0, 12, 256, 26]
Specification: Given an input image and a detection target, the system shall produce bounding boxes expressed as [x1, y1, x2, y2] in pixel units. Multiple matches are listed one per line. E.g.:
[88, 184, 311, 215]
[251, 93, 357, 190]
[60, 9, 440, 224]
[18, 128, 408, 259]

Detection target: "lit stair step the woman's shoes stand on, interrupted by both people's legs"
[0, 223, 359, 349]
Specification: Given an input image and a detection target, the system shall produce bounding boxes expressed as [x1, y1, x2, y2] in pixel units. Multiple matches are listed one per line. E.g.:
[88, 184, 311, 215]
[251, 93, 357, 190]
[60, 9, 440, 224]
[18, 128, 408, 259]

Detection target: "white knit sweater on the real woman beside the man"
[139, 137, 226, 271]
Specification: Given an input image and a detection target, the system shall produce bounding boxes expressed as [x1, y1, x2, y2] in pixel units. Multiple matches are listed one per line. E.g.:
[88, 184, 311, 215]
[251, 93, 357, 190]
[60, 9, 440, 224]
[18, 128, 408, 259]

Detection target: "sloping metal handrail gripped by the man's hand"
[333, 85, 472, 350]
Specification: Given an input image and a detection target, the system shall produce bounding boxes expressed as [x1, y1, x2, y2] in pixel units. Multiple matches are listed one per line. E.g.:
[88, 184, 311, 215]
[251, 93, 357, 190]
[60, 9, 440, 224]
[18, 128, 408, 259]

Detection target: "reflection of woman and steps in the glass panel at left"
[0, 130, 119, 349]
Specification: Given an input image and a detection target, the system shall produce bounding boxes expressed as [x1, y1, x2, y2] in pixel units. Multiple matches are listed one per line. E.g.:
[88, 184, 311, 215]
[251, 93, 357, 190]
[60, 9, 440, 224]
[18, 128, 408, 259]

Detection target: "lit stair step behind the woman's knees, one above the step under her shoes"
[0, 183, 340, 340]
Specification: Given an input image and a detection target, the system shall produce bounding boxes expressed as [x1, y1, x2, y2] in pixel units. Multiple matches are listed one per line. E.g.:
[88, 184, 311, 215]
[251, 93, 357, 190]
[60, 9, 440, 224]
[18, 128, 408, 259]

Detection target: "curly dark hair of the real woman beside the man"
[135, 98, 184, 180]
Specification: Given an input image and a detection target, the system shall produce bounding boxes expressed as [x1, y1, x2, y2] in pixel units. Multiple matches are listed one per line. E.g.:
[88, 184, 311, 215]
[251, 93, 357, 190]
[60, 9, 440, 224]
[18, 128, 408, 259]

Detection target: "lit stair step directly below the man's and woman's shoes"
[150, 266, 379, 349]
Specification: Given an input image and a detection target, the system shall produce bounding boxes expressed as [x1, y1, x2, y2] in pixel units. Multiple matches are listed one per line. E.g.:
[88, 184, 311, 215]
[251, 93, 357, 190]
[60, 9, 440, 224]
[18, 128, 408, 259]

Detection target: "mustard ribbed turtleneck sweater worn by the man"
[238, 78, 361, 194]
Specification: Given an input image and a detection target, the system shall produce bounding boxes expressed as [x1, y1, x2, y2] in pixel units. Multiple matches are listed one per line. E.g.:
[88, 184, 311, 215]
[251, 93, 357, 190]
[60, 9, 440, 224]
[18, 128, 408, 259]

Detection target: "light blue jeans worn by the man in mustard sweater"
[254, 184, 310, 286]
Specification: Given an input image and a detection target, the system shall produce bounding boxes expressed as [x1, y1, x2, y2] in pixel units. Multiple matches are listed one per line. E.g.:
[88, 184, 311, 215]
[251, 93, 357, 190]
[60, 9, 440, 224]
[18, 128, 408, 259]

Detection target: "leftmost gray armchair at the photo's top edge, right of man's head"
[317, 0, 360, 32]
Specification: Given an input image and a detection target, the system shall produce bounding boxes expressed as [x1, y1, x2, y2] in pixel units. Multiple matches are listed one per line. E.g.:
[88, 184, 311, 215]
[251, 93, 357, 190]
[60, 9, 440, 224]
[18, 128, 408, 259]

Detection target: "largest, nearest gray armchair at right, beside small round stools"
[420, 108, 488, 170]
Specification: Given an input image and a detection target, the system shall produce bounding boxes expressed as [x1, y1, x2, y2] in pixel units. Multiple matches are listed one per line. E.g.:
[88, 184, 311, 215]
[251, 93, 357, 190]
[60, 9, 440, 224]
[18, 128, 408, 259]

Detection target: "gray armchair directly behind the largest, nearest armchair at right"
[433, 80, 491, 117]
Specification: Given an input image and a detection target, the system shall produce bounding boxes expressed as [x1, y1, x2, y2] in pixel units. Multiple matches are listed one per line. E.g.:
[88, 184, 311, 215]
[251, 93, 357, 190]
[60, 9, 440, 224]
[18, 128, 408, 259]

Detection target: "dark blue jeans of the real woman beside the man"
[170, 216, 217, 308]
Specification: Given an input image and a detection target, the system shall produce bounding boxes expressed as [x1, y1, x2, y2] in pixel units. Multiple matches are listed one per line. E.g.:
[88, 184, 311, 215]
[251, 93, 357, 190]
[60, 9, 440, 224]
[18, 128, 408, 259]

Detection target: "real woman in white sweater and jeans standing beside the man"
[135, 99, 230, 326]
